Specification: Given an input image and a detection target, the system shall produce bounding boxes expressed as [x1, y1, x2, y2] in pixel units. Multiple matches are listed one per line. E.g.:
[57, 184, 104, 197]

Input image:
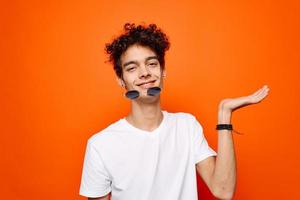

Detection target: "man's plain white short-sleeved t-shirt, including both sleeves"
[80, 111, 217, 200]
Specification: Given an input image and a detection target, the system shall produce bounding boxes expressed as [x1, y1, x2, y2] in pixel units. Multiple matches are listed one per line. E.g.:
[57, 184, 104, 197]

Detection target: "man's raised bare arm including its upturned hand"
[196, 86, 269, 199]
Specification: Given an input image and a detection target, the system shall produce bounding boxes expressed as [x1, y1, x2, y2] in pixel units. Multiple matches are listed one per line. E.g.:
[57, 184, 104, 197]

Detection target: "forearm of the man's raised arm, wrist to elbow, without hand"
[213, 108, 236, 199]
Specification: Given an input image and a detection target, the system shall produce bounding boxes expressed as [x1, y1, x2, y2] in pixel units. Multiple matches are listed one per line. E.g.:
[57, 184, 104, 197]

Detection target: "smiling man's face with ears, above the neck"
[119, 45, 165, 98]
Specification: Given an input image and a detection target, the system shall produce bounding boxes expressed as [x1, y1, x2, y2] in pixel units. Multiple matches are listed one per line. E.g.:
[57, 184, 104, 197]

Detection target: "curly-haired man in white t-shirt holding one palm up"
[80, 24, 269, 200]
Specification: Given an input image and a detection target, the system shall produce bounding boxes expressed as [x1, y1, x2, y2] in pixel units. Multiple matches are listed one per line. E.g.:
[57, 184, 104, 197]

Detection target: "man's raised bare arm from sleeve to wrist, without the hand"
[196, 110, 236, 199]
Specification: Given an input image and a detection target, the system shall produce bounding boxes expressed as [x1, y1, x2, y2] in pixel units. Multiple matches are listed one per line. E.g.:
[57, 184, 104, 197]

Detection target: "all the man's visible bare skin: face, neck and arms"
[89, 45, 269, 200]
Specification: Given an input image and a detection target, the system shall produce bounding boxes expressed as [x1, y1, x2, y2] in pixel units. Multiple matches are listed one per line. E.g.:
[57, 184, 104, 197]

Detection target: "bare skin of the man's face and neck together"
[118, 45, 166, 131]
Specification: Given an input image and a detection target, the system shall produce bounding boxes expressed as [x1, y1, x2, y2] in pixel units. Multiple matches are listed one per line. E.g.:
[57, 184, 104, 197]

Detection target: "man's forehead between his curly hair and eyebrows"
[120, 45, 156, 65]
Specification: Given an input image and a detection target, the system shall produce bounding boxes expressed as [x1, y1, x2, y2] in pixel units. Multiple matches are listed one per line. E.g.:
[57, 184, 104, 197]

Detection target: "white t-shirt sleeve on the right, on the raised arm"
[192, 118, 217, 164]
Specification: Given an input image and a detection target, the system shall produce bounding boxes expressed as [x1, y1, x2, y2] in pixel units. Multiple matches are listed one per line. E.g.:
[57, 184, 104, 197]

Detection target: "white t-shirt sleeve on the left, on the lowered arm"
[79, 142, 111, 197]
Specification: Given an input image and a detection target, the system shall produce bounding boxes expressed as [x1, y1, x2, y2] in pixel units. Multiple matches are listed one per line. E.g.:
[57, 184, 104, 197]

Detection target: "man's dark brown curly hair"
[105, 23, 170, 78]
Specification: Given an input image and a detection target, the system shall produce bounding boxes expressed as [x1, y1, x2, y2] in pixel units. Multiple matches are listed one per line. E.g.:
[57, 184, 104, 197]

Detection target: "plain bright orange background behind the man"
[0, 0, 300, 200]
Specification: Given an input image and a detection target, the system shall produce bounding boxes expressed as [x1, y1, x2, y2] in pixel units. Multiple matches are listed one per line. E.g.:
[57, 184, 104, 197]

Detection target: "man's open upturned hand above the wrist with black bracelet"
[219, 85, 270, 112]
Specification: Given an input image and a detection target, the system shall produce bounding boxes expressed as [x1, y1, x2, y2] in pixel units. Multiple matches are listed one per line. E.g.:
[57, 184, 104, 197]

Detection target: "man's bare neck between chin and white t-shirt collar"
[126, 98, 163, 131]
